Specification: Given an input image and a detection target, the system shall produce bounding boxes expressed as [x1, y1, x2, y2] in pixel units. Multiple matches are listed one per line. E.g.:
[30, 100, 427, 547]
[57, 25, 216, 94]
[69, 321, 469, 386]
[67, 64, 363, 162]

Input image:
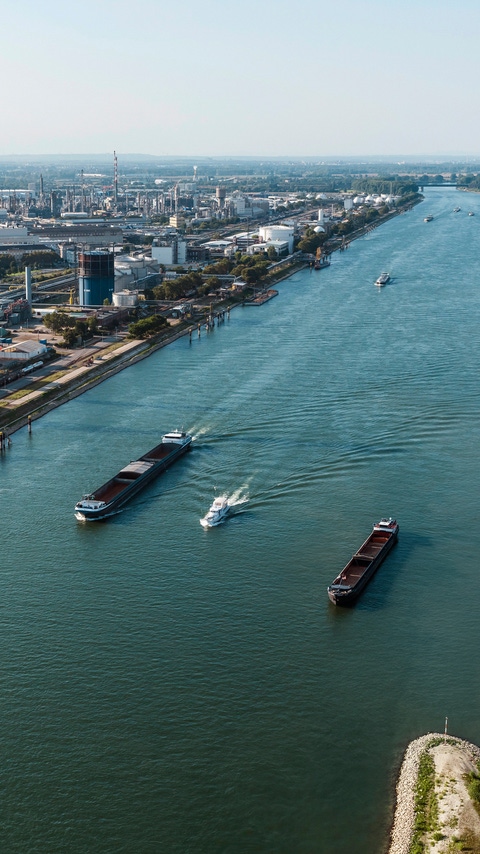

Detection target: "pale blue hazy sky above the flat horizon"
[0, 0, 480, 158]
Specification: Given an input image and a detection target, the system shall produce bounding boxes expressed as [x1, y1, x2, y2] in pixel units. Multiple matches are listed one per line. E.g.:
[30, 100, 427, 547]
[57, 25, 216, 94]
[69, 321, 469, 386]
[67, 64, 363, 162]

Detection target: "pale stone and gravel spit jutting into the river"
[388, 733, 480, 854]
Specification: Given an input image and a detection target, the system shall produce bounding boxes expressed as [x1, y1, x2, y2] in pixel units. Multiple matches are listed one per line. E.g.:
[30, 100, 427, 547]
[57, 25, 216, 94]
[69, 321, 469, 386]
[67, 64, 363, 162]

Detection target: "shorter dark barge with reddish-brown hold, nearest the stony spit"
[327, 519, 398, 605]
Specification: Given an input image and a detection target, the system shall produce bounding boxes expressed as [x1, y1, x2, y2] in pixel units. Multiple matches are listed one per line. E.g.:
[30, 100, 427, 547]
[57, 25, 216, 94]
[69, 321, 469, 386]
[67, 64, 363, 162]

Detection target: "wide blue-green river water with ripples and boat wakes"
[0, 189, 480, 854]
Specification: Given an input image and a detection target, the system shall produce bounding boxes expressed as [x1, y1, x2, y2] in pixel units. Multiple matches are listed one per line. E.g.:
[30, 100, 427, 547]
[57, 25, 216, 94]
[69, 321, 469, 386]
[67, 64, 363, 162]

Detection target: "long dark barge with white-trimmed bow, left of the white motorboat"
[75, 431, 192, 522]
